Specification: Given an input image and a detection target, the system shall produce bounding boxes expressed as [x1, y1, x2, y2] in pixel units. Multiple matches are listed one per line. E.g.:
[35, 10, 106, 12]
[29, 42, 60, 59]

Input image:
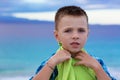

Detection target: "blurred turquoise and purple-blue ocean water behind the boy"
[0, 23, 120, 80]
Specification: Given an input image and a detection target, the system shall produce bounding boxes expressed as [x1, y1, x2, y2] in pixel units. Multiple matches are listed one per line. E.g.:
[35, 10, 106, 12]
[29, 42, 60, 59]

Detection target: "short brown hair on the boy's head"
[55, 6, 88, 30]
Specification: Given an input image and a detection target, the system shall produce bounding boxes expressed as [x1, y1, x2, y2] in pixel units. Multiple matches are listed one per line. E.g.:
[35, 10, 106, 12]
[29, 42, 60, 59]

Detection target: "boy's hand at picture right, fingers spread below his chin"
[75, 52, 101, 70]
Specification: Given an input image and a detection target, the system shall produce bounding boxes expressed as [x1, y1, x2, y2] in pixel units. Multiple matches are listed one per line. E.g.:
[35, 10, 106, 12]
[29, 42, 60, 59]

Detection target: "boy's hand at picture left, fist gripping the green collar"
[49, 50, 71, 67]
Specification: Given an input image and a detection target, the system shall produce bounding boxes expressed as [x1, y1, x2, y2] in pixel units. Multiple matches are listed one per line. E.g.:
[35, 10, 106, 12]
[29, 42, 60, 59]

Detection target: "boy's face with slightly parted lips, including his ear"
[54, 16, 89, 53]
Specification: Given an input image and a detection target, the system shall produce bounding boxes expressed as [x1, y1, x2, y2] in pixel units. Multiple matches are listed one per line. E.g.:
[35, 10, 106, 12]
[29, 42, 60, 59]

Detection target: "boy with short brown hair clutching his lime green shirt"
[31, 6, 115, 80]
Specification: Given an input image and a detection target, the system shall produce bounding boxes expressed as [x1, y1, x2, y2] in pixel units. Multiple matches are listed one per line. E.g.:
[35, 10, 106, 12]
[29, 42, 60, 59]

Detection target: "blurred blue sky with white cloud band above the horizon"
[0, 0, 120, 24]
